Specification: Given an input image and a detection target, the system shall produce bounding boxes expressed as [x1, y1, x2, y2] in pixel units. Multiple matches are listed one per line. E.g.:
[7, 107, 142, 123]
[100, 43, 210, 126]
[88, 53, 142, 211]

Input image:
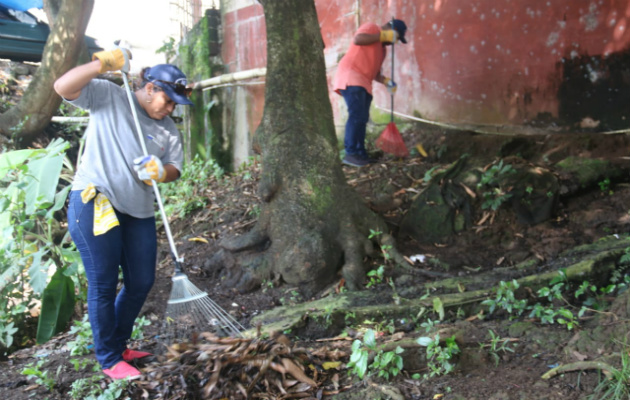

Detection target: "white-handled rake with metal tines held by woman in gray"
[122, 72, 245, 337]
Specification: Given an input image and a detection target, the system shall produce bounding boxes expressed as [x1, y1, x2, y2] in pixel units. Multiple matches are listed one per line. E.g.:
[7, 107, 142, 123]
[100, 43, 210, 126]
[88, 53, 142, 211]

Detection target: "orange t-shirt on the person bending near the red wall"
[333, 22, 386, 94]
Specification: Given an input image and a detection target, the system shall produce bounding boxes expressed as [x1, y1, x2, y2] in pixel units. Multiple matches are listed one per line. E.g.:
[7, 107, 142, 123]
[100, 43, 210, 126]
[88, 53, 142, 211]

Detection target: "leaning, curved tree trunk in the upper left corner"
[0, 0, 94, 147]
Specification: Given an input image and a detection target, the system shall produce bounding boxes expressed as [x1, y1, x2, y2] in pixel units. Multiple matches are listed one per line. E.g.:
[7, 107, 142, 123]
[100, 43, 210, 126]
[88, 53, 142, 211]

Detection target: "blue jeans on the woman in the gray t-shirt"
[68, 190, 157, 368]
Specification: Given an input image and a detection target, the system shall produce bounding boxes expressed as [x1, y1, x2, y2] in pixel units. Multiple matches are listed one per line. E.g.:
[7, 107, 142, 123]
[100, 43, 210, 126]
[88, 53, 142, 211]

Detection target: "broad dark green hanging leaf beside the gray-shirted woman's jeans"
[37, 269, 75, 344]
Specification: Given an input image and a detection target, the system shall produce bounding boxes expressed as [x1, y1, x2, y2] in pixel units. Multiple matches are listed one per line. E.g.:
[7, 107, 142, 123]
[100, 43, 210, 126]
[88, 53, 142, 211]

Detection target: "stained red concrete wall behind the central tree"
[222, 0, 630, 166]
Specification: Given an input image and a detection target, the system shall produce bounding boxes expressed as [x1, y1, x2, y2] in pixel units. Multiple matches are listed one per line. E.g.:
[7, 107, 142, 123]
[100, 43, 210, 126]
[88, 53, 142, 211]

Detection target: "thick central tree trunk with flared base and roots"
[222, 0, 387, 296]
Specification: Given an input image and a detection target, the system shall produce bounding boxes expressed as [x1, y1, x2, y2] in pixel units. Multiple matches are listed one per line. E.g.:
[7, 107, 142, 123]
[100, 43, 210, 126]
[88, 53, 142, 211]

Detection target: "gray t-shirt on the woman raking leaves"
[68, 79, 184, 218]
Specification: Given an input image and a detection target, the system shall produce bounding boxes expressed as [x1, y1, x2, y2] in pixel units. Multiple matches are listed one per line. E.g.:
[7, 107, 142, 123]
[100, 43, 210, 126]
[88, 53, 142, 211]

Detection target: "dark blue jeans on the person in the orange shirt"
[340, 86, 372, 158]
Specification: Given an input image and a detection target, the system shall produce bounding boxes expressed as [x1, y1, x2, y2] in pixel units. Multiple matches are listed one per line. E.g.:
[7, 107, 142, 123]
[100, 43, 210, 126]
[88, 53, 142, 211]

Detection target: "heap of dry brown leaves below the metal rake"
[136, 332, 348, 400]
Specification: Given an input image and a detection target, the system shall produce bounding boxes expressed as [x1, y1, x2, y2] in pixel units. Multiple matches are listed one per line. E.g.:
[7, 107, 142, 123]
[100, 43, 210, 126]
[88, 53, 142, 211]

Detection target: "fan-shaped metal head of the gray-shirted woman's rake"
[166, 273, 245, 337]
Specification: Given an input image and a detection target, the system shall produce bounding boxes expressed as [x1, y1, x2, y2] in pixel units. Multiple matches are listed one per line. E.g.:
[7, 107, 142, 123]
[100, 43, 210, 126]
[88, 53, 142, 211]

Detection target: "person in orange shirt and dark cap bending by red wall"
[333, 19, 407, 167]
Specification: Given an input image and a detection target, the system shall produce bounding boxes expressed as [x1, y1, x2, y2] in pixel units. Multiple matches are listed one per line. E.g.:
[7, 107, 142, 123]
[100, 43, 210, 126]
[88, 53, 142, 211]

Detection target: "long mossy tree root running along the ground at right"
[252, 241, 625, 335]
